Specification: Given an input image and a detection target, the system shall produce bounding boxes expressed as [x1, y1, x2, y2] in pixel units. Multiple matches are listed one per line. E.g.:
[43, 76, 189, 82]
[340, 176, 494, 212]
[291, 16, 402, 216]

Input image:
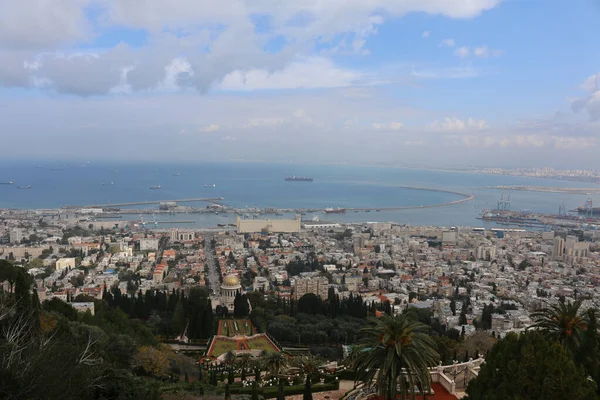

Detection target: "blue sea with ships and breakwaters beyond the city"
[0, 161, 600, 228]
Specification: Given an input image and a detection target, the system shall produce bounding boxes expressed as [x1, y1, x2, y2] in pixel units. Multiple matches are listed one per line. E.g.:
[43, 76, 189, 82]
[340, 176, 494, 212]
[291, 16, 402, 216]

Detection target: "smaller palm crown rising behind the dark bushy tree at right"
[530, 299, 588, 355]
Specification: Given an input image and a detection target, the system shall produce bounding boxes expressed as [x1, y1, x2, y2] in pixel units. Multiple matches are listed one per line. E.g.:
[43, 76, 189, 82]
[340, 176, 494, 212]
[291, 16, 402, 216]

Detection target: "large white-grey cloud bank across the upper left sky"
[0, 0, 500, 96]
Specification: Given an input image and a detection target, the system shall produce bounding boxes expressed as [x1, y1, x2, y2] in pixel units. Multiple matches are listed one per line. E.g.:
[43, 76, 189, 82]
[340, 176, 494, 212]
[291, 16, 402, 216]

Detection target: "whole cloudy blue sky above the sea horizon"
[0, 0, 600, 169]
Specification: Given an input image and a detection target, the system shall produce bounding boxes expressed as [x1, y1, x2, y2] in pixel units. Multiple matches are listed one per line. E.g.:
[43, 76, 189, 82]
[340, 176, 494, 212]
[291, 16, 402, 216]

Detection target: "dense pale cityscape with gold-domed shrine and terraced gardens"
[0, 203, 600, 399]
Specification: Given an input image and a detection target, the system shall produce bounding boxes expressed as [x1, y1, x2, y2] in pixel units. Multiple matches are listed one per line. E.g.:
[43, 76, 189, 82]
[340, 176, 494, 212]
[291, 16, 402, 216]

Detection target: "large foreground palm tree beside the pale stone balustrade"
[353, 314, 440, 400]
